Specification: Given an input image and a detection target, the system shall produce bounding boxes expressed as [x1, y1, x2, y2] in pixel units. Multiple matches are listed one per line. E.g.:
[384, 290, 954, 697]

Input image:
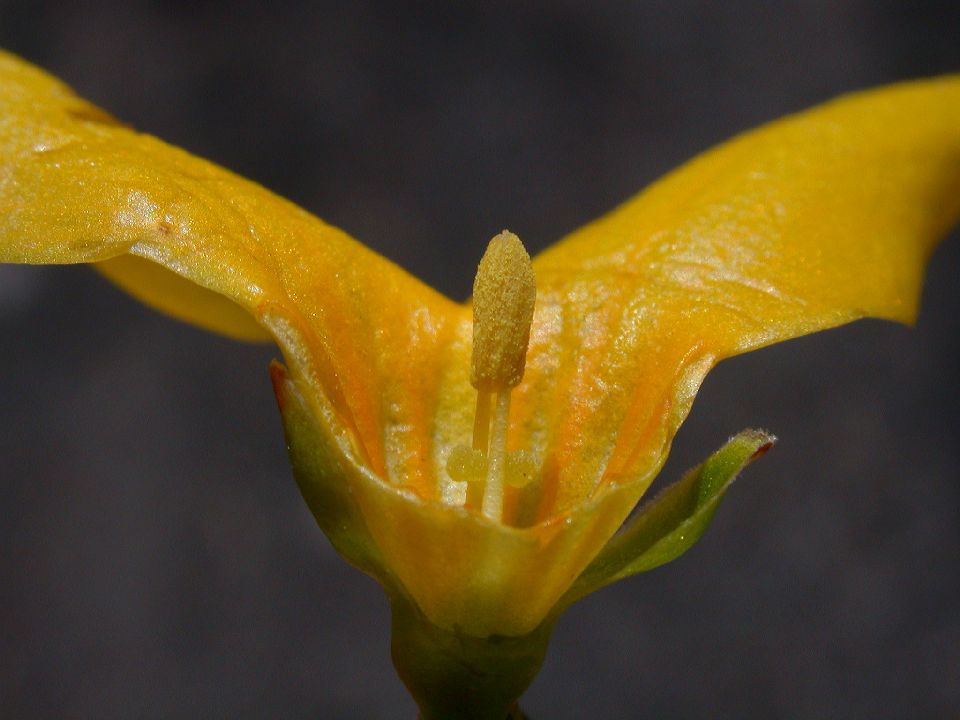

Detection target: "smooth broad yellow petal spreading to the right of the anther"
[514, 76, 960, 516]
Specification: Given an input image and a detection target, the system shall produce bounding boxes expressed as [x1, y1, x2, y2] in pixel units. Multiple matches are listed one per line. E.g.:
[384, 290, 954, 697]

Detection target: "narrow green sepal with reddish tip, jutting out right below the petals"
[558, 430, 776, 608]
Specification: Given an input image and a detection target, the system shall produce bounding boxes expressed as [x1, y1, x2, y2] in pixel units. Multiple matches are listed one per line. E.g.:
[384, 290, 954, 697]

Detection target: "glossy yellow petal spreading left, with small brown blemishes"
[0, 47, 465, 487]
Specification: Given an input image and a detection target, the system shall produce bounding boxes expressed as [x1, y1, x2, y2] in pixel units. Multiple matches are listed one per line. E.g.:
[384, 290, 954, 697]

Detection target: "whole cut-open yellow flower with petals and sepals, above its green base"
[0, 46, 960, 660]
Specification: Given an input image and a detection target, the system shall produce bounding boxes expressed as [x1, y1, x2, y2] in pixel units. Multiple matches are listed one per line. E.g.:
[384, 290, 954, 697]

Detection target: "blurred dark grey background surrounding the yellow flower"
[0, 0, 960, 720]
